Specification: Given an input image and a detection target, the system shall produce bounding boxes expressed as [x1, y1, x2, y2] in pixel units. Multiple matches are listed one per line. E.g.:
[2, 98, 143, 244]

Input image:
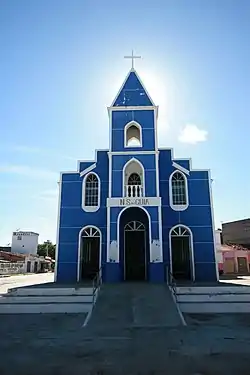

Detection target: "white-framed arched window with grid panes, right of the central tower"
[169, 171, 188, 210]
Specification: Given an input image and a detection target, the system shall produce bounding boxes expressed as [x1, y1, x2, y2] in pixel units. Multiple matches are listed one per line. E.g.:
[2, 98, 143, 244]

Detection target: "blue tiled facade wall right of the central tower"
[159, 150, 216, 281]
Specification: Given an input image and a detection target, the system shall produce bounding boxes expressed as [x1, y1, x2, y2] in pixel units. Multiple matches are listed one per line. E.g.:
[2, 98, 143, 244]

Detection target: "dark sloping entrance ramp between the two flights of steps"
[86, 283, 183, 335]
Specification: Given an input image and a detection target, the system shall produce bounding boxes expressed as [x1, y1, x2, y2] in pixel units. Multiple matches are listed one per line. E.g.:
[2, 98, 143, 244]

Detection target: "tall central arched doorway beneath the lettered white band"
[119, 207, 149, 281]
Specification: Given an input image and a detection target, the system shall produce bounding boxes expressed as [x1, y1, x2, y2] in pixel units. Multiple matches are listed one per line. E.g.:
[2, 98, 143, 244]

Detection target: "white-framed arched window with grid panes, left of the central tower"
[83, 173, 100, 211]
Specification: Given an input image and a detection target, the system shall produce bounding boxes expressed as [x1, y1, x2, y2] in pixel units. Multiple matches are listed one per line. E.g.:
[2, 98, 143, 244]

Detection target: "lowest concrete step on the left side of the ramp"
[0, 303, 92, 314]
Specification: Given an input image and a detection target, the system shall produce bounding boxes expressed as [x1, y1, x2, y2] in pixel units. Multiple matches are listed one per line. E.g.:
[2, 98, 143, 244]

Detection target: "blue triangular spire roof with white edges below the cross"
[112, 70, 154, 107]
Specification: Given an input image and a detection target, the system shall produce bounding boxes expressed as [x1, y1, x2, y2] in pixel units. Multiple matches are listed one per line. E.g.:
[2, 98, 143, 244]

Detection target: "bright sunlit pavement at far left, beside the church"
[0, 272, 54, 295]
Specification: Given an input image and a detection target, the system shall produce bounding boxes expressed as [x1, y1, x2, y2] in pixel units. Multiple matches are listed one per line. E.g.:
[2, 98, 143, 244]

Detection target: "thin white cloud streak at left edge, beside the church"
[0, 164, 59, 181]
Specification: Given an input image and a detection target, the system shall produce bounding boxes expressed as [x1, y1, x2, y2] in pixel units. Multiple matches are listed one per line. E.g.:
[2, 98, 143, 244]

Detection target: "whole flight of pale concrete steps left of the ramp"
[0, 284, 98, 314]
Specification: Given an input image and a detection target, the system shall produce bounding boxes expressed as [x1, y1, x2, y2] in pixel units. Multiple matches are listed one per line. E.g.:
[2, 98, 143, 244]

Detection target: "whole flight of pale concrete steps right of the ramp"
[176, 284, 250, 314]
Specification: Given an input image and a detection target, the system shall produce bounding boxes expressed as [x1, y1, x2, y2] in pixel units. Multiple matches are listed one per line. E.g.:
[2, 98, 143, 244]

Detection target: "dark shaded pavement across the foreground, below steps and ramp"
[0, 275, 250, 375]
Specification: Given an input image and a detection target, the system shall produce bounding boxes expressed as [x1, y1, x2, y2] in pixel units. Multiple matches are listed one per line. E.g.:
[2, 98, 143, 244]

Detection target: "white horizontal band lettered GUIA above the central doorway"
[107, 197, 161, 208]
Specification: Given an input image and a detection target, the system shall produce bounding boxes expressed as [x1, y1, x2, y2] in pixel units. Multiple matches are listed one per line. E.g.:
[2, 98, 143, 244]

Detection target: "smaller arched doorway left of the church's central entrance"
[80, 227, 101, 280]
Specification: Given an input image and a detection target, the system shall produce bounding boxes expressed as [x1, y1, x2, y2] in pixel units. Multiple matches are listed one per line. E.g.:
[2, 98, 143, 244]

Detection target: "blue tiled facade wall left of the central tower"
[57, 151, 108, 282]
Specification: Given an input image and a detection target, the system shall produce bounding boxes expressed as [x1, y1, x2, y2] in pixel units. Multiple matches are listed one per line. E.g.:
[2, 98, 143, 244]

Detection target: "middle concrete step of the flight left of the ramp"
[0, 295, 93, 308]
